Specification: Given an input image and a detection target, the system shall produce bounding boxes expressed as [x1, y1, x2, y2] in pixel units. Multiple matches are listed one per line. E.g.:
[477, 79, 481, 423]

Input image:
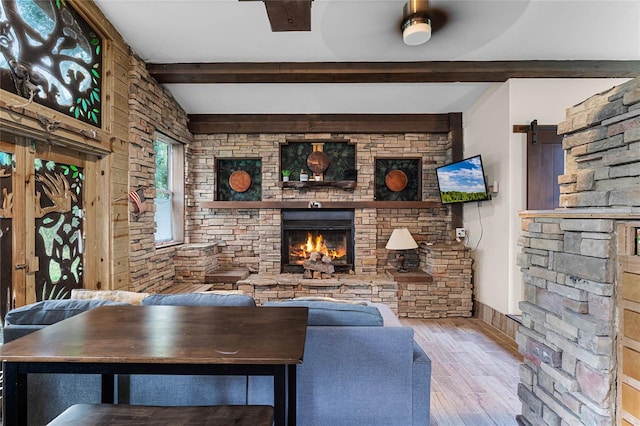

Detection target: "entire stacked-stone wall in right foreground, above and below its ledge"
[516, 79, 640, 425]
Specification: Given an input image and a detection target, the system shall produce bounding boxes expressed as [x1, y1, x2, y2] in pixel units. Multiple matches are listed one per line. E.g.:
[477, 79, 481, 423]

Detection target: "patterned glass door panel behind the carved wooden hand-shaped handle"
[35, 159, 84, 300]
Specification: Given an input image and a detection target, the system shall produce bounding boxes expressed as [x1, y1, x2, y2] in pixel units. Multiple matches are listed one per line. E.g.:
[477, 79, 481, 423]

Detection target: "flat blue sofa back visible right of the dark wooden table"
[298, 327, 414, 426]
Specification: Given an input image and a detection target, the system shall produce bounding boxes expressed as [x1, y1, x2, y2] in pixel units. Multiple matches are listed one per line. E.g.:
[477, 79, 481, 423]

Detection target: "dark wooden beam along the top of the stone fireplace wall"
[188, 113, 456, 134]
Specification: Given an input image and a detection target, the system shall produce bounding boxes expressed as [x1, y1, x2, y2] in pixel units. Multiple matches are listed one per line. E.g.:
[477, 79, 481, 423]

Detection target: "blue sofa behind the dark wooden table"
[5, 294, 431, 426]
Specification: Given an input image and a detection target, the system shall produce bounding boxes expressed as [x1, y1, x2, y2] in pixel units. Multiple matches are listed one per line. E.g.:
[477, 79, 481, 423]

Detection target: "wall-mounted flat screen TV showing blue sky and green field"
[436, 155, 489, 204]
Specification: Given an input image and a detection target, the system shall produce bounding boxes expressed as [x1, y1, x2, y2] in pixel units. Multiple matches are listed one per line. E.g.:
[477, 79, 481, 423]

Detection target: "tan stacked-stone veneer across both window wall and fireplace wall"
[124, 55, 451, 292]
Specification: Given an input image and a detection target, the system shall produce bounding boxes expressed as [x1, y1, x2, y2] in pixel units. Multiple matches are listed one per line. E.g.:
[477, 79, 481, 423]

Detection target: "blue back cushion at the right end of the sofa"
[264, 300, 383, 327]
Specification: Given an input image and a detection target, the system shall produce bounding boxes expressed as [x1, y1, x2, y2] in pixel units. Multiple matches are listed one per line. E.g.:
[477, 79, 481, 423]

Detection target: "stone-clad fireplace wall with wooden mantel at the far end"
[187, 131, 461, 275]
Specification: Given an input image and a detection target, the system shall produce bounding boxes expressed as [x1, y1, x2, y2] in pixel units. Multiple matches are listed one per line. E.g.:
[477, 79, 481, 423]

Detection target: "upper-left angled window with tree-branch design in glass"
[0, 0, 102, 127]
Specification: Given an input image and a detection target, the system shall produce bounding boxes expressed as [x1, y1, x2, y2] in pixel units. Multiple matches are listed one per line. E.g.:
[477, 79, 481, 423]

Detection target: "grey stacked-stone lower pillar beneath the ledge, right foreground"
[516, 212, 616, 425]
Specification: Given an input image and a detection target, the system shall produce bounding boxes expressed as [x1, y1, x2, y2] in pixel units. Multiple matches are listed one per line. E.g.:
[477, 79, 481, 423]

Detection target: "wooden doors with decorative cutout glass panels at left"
[0, 134, 87, 312]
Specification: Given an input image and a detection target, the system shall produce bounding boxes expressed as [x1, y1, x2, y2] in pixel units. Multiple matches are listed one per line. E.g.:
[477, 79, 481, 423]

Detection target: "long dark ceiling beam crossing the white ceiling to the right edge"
[147, 61, 640, 84]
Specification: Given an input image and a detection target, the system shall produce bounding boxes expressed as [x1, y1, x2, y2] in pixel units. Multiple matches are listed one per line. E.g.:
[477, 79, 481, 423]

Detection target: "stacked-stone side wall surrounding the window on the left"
[127, 55, 191, 292]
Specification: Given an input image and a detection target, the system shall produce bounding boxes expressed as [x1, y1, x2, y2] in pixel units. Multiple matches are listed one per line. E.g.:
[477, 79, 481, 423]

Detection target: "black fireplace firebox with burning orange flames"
[281, 209, 354, 273]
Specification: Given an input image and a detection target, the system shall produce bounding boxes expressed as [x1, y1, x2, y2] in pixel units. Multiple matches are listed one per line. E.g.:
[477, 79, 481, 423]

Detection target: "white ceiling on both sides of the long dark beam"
[95, 0, 640, 114]
